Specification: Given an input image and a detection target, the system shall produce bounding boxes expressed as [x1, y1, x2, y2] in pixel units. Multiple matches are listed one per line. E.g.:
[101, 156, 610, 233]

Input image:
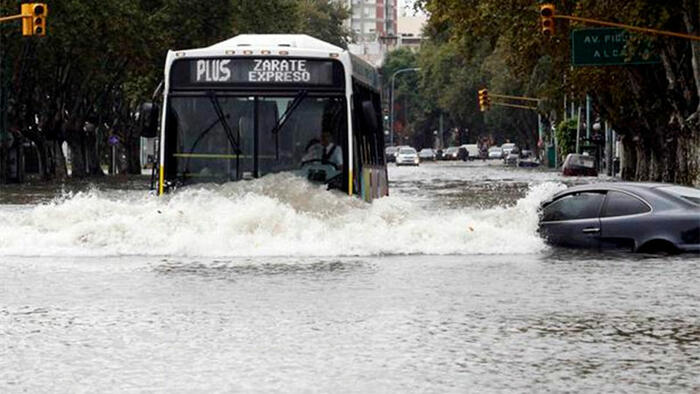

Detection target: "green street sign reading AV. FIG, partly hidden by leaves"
[571, 27, 660, 66]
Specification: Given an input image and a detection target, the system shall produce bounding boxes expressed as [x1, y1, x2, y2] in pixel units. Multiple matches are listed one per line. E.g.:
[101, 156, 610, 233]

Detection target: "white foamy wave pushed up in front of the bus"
[0, 175, 563, 257]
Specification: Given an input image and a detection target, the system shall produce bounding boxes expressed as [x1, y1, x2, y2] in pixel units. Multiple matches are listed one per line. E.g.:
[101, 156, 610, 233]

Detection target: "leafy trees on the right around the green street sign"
[419, 0, 700, 184]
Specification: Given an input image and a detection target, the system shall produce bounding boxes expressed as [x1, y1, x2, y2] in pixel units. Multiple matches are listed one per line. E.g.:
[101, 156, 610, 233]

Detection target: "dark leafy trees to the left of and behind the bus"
[0, 0, 350, 183]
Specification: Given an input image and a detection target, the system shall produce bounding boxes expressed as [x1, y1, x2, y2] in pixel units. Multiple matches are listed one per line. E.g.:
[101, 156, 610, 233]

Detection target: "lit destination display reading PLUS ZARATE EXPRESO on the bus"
[171, 58, 342, 87]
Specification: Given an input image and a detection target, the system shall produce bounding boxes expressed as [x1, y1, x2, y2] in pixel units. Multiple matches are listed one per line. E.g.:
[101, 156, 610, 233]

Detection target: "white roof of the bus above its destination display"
[166, 34, 381, 91]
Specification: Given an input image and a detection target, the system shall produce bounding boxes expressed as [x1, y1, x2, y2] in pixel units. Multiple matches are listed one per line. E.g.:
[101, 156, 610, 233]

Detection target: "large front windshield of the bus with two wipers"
[166, 92, 347, 181]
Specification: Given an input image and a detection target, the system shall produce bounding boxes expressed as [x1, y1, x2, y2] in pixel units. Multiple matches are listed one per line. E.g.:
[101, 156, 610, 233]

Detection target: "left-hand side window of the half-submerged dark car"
[542, 192, 605, 222]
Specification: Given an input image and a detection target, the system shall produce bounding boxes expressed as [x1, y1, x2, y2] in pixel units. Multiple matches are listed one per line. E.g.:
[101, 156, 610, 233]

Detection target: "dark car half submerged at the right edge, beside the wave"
[539, 183, 700, 253]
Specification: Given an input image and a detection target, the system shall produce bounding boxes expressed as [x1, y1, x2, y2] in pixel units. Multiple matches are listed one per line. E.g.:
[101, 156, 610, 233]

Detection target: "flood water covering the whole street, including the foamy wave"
[0, 162, 700, 393]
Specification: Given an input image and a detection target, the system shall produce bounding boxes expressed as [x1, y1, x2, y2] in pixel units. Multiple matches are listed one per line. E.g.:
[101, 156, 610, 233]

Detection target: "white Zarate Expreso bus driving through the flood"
[143, 34, 388, 201]
